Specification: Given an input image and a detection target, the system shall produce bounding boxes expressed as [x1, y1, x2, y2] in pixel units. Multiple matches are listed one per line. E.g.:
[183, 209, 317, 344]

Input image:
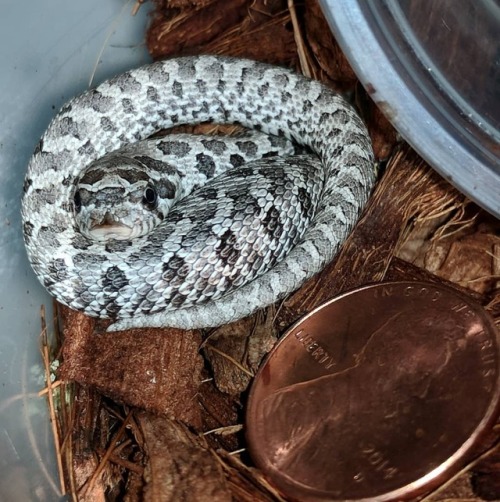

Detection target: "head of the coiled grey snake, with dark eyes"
[73, 154, 178, 242]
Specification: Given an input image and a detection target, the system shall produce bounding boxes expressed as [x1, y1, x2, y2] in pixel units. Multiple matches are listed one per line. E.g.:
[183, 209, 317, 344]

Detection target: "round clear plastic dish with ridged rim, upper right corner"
[321, 0, 500, 217]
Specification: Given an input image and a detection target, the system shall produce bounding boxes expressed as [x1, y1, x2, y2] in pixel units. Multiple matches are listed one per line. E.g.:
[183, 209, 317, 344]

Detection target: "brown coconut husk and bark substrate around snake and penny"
[40, 0, 500, 502]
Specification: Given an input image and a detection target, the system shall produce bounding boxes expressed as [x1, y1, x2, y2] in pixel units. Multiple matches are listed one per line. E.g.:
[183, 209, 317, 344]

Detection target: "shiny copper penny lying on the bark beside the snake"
[246, 282, 500, 501]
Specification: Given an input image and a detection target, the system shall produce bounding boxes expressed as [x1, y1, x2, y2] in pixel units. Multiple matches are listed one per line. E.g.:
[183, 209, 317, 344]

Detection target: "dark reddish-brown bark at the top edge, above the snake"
[147, 0, 297, 65]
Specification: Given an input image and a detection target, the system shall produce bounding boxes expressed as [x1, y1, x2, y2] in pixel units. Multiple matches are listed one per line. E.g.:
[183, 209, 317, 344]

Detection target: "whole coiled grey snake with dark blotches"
[22, 56, 375, 330]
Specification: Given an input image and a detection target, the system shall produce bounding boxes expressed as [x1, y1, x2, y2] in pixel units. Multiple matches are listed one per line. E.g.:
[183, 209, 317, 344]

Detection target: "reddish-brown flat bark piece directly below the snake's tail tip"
[60, 308, 203, 426]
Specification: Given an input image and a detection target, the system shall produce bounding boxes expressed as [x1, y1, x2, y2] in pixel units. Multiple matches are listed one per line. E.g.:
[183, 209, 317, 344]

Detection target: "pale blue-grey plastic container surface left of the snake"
[0, 0, 149, 502]
